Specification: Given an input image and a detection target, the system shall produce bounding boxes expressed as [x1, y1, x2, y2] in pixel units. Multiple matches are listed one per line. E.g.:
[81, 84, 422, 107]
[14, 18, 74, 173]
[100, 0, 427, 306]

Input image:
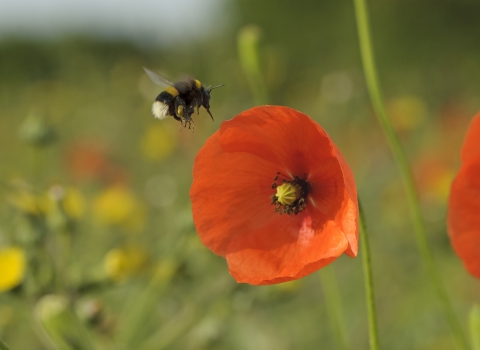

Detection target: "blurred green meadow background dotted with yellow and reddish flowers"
[0, 0, 480, 350]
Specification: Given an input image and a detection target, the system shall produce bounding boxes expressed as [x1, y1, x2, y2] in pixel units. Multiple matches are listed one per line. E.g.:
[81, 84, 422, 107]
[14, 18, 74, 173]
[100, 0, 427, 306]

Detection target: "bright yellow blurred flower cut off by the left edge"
[0, 247, 25, 292]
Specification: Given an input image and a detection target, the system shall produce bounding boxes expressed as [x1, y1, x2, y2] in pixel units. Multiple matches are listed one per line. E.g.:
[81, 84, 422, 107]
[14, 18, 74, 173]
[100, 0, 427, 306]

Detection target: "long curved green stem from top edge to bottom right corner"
[353, 0, 468, 349]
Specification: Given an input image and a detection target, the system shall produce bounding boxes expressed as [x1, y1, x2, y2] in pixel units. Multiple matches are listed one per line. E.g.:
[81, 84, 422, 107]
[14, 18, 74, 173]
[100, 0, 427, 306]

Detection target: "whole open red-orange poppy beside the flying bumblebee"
[190, 106, 358, 285]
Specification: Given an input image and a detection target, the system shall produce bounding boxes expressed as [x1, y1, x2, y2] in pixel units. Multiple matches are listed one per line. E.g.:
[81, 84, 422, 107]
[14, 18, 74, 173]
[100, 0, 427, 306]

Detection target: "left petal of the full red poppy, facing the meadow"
[190, 132, 278, 256]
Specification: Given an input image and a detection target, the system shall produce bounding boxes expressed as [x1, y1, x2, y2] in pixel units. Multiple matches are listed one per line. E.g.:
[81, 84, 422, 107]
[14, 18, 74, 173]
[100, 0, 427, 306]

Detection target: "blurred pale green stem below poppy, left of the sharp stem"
[320, 266, 350, 350]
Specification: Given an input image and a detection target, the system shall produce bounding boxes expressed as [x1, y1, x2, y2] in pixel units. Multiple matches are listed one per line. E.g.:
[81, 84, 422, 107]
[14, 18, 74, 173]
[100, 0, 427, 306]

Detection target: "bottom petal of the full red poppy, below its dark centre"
[226, 213, 348, 285]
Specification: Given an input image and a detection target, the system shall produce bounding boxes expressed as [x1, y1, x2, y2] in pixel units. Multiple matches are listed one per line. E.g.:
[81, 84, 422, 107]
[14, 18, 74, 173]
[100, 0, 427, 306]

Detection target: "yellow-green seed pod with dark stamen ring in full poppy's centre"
[272, 173, 310, 215]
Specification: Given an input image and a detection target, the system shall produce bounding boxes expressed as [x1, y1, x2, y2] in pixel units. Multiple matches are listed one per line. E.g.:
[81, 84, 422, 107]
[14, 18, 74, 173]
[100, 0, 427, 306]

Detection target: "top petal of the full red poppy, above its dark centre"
[220, 106, 335, 176]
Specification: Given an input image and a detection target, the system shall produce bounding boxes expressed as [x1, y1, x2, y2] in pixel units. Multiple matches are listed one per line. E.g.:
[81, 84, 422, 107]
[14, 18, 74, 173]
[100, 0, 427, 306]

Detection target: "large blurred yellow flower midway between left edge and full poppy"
[93, 185, 145, 230]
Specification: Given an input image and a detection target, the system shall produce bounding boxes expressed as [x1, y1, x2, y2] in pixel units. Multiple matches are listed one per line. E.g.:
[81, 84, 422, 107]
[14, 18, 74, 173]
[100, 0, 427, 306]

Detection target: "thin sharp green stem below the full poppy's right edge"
[358, 203, 378, 350]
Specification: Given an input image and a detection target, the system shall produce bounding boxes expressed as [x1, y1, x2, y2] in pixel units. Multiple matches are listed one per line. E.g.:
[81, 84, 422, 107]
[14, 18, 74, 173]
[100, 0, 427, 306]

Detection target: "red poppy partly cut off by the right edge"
[448, 113, 480, 278]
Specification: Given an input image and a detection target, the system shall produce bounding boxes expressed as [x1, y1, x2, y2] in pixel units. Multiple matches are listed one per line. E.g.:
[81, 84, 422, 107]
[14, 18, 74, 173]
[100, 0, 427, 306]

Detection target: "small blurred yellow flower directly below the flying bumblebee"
[140, 123, 177, 161]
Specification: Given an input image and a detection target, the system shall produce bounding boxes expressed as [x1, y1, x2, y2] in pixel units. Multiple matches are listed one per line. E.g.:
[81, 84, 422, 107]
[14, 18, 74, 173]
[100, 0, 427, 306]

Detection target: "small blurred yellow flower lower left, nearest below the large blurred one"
[104, 247, 148, 281]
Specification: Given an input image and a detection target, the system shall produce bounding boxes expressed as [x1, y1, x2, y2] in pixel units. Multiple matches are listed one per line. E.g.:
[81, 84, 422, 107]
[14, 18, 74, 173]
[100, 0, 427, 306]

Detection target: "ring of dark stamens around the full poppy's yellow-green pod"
[271, 172, 310, 215]
